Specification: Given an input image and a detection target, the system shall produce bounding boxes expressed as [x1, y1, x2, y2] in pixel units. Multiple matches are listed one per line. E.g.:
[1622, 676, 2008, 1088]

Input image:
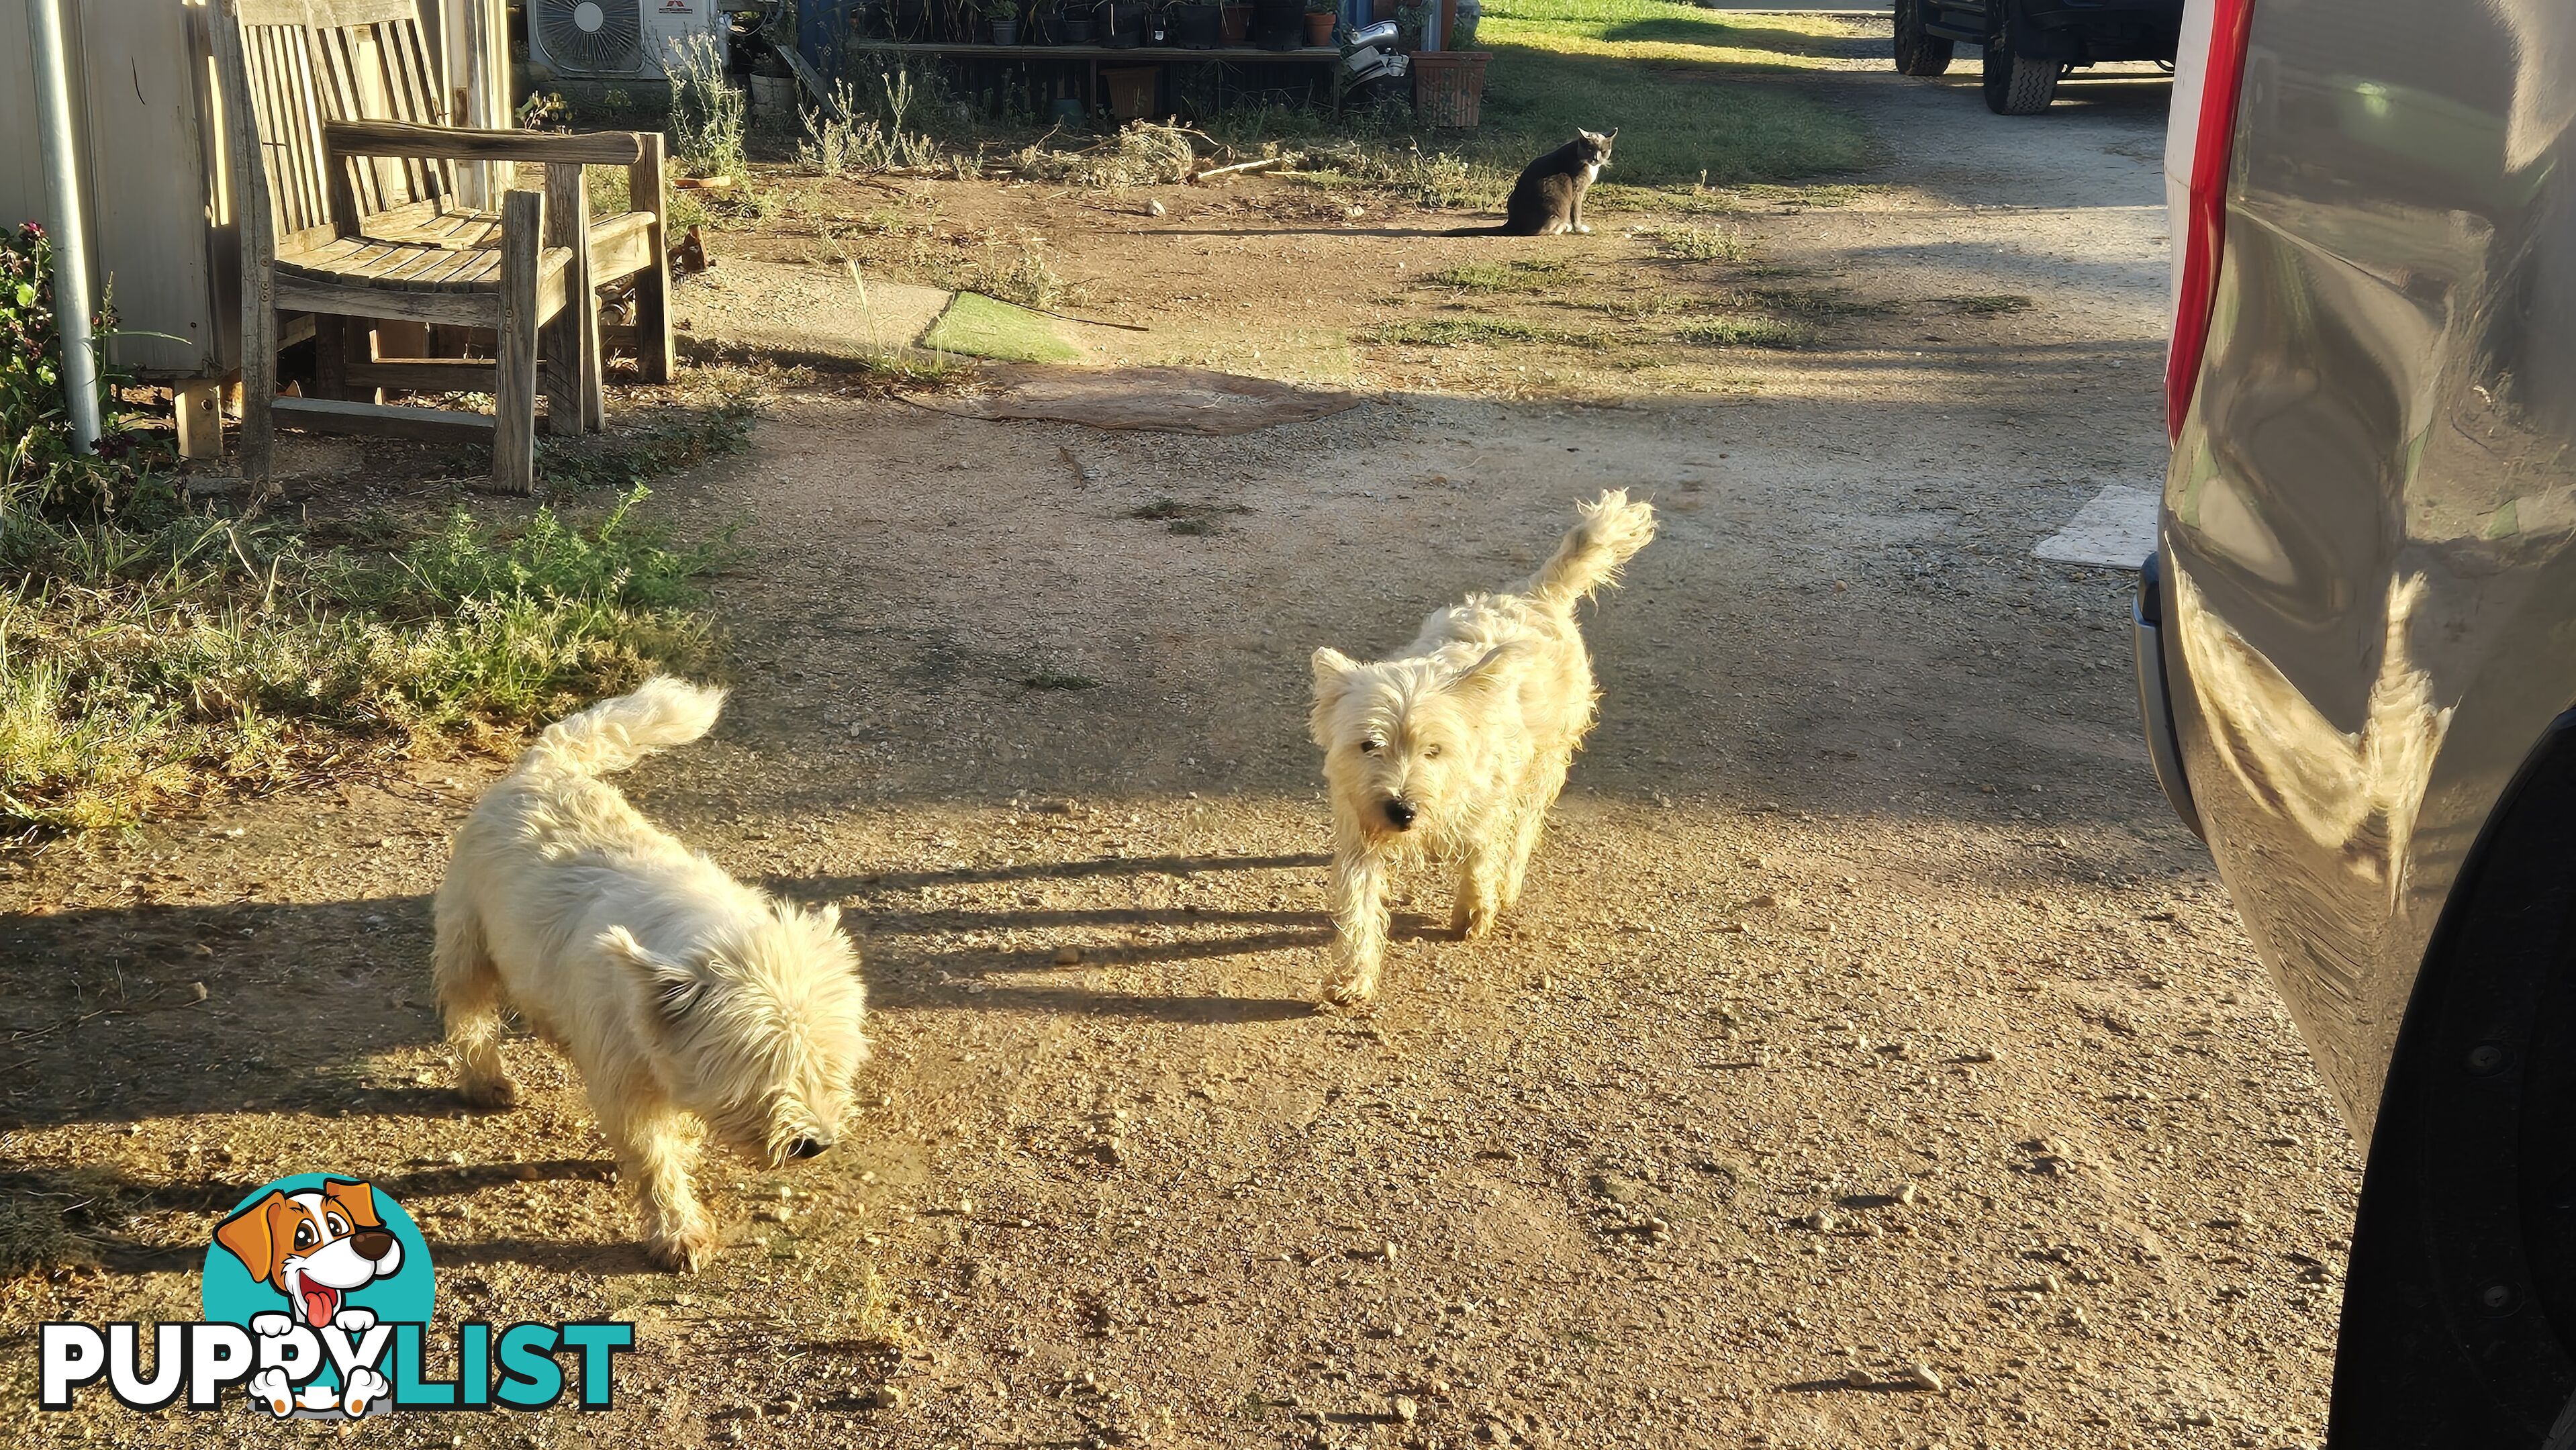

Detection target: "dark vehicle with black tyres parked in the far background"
[1896, 0, 2182, 116]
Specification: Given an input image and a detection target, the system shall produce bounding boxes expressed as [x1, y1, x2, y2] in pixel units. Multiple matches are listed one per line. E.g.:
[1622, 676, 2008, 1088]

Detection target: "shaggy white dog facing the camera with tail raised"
[1308, 489, 1654, 1007]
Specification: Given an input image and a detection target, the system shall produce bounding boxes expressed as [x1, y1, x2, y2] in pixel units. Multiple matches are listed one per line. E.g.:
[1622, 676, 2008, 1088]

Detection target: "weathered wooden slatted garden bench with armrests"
[211, 0, 672, 492]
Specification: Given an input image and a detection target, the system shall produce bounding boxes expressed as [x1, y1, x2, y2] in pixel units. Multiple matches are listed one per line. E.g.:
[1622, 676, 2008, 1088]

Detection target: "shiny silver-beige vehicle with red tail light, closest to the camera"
[2138, 0, 2576, 1450]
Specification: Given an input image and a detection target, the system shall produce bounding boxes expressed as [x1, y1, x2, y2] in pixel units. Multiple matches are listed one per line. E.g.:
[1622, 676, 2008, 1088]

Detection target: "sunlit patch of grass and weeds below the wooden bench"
[0, 489, 732, 829]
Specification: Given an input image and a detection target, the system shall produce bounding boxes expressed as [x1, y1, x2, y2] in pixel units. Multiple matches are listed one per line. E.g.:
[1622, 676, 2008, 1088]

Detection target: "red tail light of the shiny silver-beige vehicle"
[2164, 0, 2254, 440]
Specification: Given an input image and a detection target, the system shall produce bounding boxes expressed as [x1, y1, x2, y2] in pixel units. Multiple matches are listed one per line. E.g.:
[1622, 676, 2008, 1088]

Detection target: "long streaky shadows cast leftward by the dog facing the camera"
[763, 853, 1447, 1025]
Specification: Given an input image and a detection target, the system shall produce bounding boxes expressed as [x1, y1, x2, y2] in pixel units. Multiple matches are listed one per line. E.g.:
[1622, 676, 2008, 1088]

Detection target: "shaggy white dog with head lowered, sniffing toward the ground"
[435, 677, 868, 1269]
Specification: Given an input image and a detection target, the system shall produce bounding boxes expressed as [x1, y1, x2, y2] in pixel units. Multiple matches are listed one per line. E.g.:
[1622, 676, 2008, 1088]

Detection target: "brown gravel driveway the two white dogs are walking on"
[0, 45, 2357, 1450]
